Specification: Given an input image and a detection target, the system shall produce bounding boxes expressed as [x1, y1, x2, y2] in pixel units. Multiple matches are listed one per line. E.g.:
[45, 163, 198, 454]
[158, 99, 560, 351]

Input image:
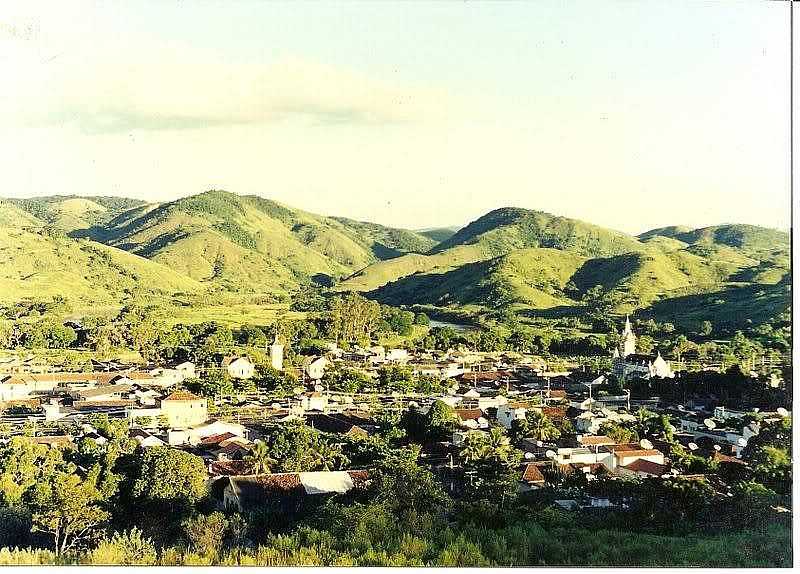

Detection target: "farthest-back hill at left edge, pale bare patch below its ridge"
[4, 195, 145, 232]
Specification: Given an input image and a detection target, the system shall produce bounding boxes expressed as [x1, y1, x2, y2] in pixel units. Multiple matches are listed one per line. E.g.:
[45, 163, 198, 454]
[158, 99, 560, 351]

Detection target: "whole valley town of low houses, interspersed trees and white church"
[0, 304, 791, 564]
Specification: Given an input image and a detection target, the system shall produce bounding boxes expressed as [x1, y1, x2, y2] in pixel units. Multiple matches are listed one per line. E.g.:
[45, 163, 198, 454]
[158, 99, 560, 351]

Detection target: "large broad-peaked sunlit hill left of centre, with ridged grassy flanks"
[83, 191, 432, 292]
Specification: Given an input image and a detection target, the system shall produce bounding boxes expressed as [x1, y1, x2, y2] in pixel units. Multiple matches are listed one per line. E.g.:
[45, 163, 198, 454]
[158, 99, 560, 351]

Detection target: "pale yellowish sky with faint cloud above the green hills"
[0, 0, 790, 233]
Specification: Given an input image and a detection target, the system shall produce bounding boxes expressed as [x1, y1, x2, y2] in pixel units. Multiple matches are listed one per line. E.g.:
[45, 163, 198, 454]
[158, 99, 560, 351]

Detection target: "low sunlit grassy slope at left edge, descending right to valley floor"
[0, 226, 201, 306]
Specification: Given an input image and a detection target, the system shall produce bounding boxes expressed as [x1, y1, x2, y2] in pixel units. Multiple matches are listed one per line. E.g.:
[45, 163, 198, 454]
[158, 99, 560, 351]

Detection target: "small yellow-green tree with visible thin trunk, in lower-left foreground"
[32, 472, 110, 555]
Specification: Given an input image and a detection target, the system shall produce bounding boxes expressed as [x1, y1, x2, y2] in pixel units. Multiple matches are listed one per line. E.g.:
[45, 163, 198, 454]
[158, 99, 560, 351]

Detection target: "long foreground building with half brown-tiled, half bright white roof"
[217, 470, 369, 512]
